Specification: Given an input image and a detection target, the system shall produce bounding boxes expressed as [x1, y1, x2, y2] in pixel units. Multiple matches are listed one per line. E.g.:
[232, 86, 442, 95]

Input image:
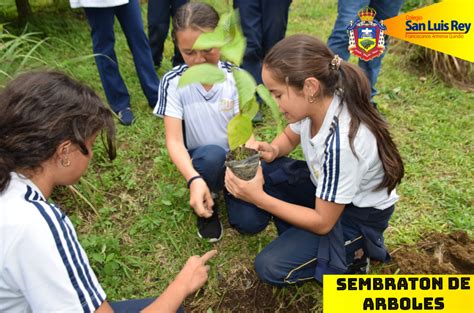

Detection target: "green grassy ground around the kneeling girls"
[0, 0, 474, 311]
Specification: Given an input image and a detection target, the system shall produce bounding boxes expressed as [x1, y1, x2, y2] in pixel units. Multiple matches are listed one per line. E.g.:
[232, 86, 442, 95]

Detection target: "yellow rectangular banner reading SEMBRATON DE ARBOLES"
[323, 275, 474, 313]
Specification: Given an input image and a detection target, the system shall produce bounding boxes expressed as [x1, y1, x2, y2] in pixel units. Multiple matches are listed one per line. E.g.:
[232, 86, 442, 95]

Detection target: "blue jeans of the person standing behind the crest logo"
[328, 0, 404, 97]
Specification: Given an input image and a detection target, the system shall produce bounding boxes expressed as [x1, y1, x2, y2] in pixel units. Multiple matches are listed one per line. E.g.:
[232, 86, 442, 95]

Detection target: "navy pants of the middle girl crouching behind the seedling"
[189, 145, 271, 234]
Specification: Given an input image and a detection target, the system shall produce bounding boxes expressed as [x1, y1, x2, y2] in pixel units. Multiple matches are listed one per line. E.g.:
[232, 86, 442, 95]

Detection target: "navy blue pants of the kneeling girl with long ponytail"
[228, 158, 393, 286]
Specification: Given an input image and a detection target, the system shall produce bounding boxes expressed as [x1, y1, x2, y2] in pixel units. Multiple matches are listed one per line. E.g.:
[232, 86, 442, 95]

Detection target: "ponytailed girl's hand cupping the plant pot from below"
[225, 166, 265, 203]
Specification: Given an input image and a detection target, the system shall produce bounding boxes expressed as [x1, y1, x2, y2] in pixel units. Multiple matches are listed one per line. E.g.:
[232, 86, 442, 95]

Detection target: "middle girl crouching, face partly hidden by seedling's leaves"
[154, 3, 265, 242]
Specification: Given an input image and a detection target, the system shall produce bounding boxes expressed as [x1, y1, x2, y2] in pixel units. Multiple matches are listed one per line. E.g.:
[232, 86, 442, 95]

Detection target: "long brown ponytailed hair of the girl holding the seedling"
[263, 35, 404, 193]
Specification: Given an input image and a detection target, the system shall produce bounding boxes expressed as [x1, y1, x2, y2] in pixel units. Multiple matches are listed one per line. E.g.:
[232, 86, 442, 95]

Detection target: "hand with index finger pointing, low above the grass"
[175, 250, 217, 295]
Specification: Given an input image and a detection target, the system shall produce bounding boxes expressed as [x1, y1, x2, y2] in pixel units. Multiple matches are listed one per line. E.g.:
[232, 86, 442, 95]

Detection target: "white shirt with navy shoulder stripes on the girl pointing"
[0, 173, 106, 313]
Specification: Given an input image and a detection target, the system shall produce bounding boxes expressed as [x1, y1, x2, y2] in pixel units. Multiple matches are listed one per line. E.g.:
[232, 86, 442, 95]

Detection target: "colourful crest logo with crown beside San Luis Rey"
[347, 7, 387, 61]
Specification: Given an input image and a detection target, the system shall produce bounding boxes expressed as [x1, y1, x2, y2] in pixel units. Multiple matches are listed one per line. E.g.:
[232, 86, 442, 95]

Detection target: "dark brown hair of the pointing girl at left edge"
[0, 71, 115, 192]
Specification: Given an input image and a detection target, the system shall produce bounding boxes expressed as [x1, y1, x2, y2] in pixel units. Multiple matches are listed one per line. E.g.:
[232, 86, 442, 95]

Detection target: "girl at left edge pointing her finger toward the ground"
[0, 72, 216, 313]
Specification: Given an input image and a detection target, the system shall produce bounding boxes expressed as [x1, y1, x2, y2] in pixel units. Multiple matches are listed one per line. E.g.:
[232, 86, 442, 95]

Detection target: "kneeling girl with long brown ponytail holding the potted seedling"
[225, 35, 403, 286]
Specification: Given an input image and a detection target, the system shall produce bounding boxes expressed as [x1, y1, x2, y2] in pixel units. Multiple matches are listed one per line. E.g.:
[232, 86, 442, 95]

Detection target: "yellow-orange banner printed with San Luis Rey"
[383, 0, 474, 62]
